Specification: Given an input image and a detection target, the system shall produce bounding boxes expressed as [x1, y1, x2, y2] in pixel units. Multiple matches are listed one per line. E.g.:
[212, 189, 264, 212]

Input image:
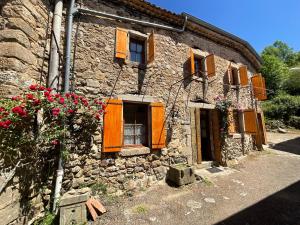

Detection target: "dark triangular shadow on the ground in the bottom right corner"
[215, 181, 300, 225]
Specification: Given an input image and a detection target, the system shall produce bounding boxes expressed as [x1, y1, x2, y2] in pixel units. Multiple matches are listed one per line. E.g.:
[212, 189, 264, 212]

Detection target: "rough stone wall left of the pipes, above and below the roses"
[0, 0, 51, 224]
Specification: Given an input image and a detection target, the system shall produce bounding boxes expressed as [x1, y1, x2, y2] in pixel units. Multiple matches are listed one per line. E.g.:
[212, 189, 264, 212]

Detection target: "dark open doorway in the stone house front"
[200, 109, 213, 161]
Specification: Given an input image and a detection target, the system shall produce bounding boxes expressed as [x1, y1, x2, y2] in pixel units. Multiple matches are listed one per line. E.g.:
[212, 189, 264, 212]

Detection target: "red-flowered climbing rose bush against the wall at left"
[0, 84, 105, 163]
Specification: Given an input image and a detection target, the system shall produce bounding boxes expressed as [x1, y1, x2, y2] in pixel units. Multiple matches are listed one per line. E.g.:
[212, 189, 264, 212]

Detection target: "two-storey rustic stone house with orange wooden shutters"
[0, 0, 266, 222]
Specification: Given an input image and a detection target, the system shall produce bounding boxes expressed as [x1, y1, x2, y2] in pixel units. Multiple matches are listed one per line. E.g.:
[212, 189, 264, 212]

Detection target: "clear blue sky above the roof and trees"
[148, 0, 300, 53]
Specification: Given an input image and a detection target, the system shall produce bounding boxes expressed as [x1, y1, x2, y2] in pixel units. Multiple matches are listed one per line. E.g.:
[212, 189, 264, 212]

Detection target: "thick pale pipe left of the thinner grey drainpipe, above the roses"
[47, 0, 63, 90]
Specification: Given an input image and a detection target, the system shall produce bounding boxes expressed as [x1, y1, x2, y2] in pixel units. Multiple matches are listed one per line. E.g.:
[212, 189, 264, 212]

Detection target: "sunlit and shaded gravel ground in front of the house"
[97, 132, 300, 225]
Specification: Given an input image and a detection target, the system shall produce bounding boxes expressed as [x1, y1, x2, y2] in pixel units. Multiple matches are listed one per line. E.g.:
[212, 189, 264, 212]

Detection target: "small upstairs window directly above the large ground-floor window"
[129, 37, 145, 64]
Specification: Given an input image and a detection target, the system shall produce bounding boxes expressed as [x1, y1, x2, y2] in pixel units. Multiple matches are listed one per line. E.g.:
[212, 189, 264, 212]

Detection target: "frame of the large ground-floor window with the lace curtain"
[122, 101, 150, 149]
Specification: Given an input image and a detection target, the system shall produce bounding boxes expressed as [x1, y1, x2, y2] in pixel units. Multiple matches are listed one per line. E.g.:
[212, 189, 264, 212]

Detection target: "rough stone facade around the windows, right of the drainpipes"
[59, 1, 255, 191]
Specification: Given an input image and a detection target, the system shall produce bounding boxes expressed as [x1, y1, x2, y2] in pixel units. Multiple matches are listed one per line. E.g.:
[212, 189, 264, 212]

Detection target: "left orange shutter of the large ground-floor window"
[102, 99, 123, 152]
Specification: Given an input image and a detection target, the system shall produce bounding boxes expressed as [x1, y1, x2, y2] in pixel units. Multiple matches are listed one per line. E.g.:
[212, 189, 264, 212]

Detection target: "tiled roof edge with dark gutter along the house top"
[119, 0, 262, 69]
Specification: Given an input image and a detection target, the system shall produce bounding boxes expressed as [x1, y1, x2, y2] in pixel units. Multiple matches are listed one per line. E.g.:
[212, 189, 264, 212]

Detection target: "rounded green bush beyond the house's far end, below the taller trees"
[262, 94, 300, 122]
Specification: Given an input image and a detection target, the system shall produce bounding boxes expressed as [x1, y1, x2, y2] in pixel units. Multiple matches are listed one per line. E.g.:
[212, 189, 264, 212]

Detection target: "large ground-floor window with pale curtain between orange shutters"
[123, 103, 148, 146]
